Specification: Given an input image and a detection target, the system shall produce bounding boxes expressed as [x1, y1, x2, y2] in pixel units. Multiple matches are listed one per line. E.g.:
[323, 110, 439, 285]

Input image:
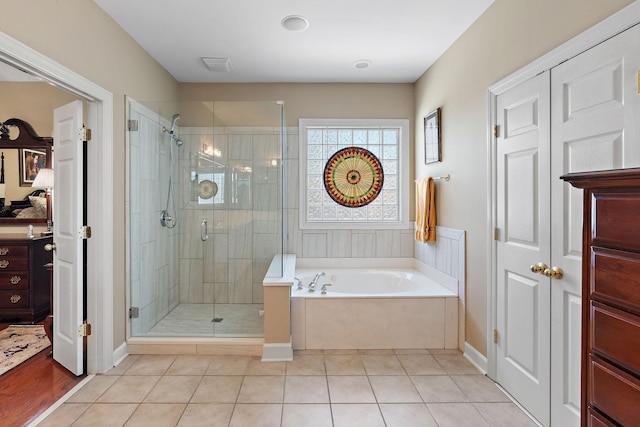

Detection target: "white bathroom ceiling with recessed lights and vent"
[95, 0, 493, 83]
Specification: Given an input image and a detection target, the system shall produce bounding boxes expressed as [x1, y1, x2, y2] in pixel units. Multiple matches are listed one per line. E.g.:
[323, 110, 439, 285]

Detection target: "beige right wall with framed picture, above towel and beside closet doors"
[415, 0, 632, 355]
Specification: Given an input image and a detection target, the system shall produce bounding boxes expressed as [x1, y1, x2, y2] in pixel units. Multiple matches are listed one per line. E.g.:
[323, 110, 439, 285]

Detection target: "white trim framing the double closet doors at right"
[487, 0, 640, 378]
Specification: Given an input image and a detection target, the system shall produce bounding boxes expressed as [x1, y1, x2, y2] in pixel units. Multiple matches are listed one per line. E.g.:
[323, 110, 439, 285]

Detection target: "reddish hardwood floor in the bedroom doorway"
[0, 323, 84, 427]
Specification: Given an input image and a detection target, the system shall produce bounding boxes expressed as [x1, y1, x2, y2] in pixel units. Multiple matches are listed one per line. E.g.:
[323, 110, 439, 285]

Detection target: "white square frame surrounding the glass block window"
[298, 119, 412, 230]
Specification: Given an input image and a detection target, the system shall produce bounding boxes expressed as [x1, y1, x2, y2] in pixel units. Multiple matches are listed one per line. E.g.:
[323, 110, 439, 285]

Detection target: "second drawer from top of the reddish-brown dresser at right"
[589, 246, 640, 314]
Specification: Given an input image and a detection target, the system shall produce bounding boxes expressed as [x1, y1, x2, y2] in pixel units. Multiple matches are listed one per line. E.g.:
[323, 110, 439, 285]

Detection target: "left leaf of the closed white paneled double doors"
[495, 68, 551, 425]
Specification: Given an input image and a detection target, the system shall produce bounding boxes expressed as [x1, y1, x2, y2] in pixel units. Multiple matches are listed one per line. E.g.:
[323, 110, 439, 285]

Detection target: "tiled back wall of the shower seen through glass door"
[179, 127, 282, 304]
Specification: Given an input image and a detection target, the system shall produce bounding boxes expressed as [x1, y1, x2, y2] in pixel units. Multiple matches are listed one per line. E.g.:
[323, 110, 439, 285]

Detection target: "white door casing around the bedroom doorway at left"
[0, 32, 113, 374]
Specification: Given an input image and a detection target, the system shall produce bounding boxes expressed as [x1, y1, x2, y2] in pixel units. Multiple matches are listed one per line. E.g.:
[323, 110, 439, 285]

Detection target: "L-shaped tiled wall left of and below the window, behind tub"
[285, 127, 413, 258]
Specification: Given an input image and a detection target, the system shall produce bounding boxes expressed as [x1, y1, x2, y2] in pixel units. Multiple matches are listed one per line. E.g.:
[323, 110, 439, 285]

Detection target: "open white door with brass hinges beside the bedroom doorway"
[53, 101, 84, 375]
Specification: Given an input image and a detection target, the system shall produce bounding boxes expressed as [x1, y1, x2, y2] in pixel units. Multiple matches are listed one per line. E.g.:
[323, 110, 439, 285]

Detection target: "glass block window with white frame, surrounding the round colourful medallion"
[299, 119, 409, 228]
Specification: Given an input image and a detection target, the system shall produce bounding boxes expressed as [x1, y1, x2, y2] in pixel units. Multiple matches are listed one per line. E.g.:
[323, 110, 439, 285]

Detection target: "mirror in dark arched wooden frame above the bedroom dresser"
[0, 119, 53, 224]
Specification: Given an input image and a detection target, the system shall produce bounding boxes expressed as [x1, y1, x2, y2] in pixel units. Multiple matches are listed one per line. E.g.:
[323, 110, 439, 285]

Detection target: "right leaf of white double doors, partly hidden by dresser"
[551, 26, 640, 426]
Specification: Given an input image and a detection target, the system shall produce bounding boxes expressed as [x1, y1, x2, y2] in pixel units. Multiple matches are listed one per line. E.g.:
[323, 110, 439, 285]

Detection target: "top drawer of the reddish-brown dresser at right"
[591, 190, 640, 250]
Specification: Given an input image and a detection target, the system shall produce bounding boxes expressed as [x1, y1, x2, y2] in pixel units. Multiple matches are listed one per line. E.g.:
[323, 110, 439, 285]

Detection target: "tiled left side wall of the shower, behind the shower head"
[128, 103, 179, 335]
